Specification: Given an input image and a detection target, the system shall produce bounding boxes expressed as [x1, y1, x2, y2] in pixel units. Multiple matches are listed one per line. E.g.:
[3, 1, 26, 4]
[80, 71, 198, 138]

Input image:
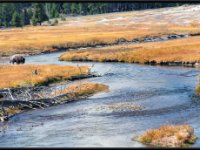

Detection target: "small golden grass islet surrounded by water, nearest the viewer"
[139, 125, 197, 147]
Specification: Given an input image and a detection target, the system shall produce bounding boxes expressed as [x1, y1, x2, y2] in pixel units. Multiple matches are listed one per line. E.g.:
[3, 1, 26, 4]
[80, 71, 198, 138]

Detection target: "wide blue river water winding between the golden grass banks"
[0, 53, 200, 147]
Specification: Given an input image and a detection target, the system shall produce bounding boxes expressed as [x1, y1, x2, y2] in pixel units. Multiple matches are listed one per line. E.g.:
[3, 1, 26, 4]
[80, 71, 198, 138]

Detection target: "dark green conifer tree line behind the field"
[0, 2, 197, 27]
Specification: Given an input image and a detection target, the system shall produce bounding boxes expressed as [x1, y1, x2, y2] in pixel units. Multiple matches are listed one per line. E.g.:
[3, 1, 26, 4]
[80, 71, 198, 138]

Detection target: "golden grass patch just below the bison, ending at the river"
[0, 65, 89, 88]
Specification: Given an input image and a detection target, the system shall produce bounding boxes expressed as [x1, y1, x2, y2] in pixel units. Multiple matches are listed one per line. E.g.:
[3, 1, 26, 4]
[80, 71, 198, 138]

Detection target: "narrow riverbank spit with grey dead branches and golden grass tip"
[0, 82, 109, 121]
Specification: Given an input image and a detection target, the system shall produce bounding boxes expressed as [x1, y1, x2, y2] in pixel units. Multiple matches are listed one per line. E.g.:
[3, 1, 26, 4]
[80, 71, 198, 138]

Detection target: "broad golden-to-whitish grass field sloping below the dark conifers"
[0, 5, 200, 57]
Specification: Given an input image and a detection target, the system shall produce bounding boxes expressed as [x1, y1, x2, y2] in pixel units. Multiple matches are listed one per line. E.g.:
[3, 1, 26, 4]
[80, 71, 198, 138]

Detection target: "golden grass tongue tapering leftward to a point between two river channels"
[59, 37, 200, 63]
